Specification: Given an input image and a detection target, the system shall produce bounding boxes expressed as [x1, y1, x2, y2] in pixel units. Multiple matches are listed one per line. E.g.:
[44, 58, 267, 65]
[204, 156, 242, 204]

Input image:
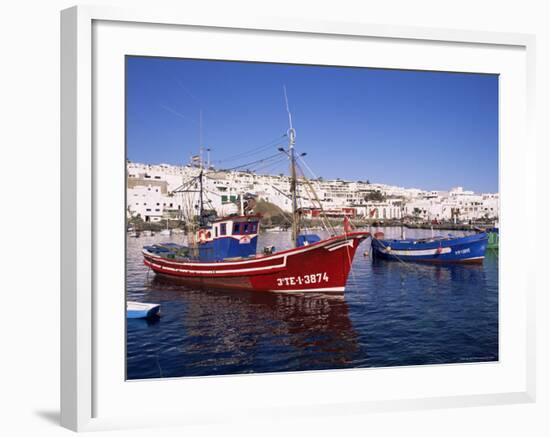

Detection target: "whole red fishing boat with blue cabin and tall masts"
[143, 92, 370, 293]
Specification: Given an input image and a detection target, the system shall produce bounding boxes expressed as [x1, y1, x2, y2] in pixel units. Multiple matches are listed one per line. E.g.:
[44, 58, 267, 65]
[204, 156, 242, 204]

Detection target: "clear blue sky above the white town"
[126, 57, 498, 192]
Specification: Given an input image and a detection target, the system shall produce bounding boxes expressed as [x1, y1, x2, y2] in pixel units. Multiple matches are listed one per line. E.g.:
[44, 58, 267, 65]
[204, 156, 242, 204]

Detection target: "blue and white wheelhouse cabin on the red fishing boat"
[197, 215, 260, 261]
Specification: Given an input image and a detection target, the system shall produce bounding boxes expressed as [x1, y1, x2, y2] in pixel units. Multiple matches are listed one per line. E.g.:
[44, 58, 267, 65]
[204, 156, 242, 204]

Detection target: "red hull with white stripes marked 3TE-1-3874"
[143, 232, 369, 293]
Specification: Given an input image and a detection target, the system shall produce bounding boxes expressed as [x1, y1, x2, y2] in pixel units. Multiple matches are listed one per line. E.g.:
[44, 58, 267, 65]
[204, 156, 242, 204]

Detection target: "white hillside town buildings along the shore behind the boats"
[126, 162, 499, 224]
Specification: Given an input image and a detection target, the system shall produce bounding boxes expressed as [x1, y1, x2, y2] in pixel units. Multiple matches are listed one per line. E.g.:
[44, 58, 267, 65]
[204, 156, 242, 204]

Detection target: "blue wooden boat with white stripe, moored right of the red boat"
[371, 232, 488, 263]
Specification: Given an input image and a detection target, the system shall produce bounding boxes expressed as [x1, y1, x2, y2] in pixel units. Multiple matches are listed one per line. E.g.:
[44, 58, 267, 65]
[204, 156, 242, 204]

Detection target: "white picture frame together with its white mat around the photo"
[61, 6, 535, 430]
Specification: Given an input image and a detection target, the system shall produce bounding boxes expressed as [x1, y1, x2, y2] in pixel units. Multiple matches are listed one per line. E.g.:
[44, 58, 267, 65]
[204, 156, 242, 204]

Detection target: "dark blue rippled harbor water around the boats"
[126, 228, 498, 379]
